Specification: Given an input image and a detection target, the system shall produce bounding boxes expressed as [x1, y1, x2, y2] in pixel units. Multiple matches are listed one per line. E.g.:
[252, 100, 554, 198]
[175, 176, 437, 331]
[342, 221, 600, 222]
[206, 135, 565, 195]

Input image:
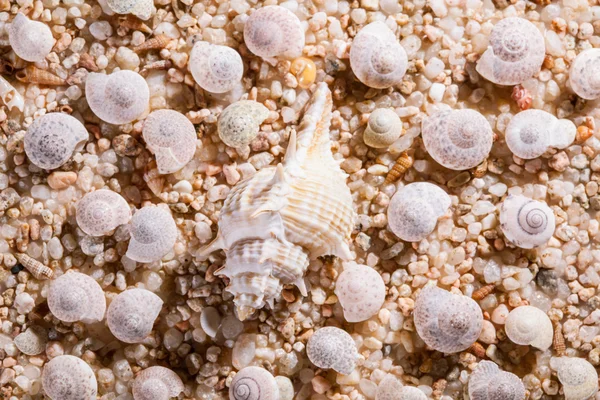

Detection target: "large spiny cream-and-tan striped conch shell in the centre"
[199, 83, 354, 319]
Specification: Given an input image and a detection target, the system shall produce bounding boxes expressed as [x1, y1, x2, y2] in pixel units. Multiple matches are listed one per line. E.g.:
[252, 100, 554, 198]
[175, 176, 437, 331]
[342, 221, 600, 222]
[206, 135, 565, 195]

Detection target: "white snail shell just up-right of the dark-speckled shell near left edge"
[85, 70, 150, 125]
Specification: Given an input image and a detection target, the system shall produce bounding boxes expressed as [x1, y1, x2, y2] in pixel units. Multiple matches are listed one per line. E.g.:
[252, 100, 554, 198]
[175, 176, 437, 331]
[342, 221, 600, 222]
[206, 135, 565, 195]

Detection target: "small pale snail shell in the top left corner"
[7, 13, 54, 62]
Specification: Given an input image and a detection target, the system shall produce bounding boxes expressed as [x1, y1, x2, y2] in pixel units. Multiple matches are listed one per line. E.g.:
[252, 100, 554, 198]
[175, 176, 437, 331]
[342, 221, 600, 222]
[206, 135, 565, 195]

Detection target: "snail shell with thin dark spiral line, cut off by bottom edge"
[229, 366, 279, 400]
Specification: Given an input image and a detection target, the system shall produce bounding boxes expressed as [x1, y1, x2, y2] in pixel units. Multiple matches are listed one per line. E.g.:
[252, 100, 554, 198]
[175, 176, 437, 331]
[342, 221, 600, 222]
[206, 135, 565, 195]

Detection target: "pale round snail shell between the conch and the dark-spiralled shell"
[387, 182, 451, 242]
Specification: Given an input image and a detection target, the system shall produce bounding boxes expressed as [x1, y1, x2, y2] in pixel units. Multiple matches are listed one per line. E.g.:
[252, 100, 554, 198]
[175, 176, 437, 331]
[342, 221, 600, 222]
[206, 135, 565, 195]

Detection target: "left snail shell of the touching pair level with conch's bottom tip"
[48, 271, 106, 323]
